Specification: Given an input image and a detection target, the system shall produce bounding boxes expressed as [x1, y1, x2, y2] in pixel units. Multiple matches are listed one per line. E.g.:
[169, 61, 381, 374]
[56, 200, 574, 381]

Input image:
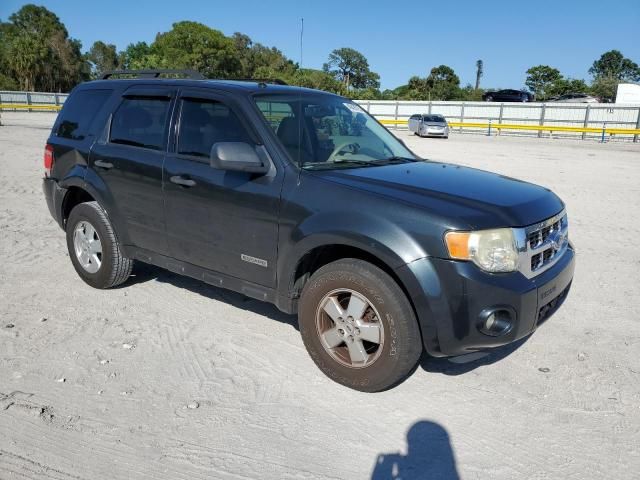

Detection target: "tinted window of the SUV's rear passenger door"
[110, 97, 169, 150]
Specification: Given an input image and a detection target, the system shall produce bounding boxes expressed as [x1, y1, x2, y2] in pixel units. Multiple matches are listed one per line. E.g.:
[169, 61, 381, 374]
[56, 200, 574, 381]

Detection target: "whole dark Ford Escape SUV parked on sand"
[43, 71, 574, 392]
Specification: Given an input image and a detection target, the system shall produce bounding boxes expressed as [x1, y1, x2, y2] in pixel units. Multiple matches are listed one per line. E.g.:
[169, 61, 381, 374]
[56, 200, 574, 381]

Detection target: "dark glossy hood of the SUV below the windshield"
[313, 161, 564, 229]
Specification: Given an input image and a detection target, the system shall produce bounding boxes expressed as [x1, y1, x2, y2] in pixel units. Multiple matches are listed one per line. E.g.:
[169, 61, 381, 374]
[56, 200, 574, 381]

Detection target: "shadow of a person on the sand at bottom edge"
[371, 420, 460, 480]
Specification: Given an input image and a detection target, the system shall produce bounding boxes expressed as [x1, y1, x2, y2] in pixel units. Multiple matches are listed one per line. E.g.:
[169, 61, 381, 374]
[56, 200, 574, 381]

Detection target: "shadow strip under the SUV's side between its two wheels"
[123, 262, 298, 330]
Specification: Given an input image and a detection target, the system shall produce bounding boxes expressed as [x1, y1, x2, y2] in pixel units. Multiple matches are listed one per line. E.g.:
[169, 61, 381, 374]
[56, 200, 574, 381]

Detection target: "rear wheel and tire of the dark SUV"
[66, 202, 133, 289]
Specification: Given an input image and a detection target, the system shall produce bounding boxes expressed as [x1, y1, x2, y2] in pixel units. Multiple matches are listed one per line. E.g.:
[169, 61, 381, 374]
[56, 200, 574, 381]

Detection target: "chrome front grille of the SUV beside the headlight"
[512, 209, 569, 279]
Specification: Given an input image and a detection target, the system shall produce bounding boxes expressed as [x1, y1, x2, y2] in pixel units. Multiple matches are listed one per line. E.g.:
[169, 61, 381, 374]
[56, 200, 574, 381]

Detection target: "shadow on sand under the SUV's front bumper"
[420, 335, 531, 376]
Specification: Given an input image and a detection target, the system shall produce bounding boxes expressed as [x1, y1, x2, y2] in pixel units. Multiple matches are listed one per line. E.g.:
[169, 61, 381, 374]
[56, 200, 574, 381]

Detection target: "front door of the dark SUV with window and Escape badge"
[164, 89, 284, 287]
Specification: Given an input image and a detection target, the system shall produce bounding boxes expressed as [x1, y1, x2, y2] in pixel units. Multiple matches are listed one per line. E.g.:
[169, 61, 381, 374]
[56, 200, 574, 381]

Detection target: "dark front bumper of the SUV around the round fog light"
[398, 245, 575, 357]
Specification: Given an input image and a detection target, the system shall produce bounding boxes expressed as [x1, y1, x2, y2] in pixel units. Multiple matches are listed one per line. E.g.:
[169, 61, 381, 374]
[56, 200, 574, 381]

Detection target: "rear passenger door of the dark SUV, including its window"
[90, 85, 175, 254]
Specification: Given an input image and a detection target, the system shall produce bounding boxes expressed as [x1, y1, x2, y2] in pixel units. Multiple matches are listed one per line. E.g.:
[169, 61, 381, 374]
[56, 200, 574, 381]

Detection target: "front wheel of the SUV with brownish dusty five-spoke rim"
[298, 258, 422, 392]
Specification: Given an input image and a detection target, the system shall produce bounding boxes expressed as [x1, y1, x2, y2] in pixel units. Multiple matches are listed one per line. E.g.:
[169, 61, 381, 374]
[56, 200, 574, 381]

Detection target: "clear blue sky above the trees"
[0, 0, 640, 88]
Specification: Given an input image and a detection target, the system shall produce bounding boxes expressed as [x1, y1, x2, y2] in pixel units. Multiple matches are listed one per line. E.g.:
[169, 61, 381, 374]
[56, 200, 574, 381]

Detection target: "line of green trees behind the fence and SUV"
[0, 5, 640, 101]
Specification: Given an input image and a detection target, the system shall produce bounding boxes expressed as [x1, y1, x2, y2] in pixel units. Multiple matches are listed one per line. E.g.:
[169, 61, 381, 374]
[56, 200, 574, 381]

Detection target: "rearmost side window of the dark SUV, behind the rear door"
[56, 89, 113, 140]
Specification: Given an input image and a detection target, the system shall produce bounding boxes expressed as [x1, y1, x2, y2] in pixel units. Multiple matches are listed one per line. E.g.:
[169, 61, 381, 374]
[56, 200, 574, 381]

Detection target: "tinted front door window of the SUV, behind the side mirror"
[178, 100, 253, 158]
